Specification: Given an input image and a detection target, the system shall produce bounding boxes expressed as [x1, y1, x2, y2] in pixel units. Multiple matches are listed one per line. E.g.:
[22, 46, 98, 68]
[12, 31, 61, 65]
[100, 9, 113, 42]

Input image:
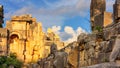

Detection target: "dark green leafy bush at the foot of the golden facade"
[0, 54, 22, 68]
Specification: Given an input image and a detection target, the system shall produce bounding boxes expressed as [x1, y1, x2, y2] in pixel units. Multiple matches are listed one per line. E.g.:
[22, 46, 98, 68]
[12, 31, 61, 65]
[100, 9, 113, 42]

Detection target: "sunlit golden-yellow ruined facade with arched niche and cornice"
[0, 15, 64, 63]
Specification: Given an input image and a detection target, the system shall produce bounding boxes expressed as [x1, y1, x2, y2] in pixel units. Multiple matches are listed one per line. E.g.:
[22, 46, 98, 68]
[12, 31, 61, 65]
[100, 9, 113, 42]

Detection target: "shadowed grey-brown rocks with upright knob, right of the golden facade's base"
[38, 44, 68, 68]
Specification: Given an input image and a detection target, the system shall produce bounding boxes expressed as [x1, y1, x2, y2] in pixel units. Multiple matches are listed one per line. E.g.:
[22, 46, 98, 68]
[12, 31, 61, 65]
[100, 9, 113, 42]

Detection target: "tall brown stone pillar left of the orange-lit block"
[90, 0, 106, 30]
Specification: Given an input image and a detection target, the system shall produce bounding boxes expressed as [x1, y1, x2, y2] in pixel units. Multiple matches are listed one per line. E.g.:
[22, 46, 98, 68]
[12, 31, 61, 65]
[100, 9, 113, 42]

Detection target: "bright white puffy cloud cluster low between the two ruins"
[51, 26, 87, 43]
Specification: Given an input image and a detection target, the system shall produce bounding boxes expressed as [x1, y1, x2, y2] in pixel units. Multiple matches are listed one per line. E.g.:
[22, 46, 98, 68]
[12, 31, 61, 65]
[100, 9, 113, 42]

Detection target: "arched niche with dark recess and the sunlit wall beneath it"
[9, 32, 25, 61]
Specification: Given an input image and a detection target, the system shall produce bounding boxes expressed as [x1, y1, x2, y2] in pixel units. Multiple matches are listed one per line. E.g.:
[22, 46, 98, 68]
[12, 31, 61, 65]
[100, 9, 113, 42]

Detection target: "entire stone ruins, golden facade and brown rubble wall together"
[0, 0, 120, 68]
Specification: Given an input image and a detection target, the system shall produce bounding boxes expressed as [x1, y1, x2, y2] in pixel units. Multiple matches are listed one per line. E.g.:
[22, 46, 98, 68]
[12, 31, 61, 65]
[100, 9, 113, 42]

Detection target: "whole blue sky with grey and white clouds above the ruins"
[0, 0, 114, 40]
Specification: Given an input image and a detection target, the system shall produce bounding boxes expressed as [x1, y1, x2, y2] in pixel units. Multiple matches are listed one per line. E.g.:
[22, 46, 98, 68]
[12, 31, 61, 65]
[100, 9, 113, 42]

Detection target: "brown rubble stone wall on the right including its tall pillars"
[59, 0, 120, 68]
